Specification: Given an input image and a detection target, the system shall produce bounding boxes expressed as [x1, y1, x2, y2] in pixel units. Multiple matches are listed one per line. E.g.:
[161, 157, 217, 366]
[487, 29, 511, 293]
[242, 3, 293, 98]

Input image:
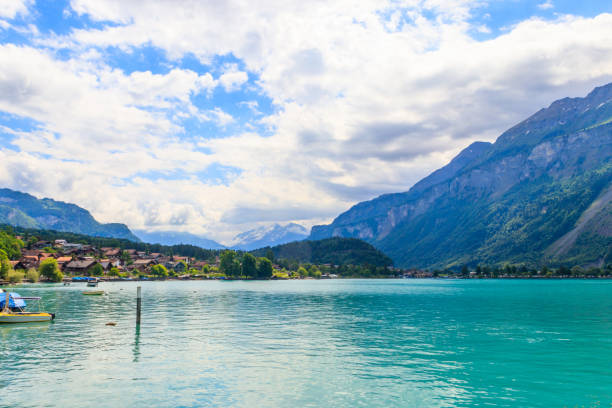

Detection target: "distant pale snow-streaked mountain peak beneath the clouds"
[232, 223, 308, 251]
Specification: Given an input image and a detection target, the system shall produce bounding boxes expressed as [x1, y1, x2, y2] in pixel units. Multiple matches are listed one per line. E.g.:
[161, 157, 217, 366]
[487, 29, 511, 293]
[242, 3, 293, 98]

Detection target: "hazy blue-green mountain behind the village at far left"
[0, 188, 140, 242]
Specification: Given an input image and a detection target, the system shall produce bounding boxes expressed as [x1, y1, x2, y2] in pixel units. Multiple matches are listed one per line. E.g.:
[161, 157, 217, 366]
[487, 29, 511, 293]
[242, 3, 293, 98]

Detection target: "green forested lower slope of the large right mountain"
[380, 163, 612, 267]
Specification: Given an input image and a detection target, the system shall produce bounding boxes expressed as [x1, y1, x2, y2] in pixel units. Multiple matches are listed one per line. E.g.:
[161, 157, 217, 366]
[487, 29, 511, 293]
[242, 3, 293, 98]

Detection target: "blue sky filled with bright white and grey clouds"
[0, 0, 612, 243]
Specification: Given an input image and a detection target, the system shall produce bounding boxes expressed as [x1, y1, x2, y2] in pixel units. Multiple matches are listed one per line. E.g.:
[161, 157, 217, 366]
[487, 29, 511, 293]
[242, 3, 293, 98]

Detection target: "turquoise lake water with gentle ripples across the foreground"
[0, 280, 612, 407]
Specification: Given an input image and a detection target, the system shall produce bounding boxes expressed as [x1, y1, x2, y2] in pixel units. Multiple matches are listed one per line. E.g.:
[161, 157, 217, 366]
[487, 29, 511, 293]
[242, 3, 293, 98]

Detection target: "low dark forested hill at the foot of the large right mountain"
[253, 238, 393, 266]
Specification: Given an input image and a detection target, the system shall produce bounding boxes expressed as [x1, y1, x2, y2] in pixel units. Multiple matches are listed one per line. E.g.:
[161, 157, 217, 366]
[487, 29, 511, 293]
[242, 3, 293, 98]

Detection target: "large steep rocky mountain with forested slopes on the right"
[309, 84, 612, 268]
